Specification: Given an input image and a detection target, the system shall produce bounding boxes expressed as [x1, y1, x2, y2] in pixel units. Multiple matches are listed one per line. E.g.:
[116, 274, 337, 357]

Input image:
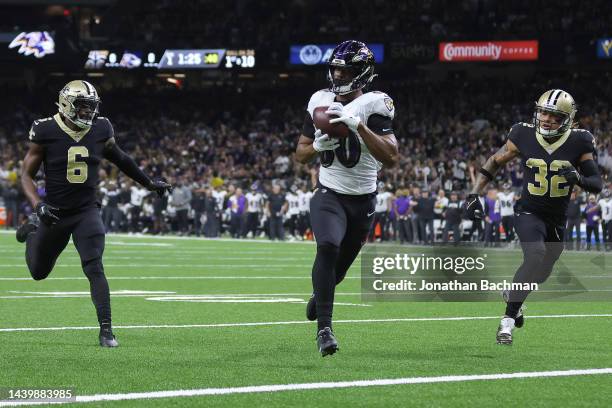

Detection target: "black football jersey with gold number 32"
[508, 123, 595, 224]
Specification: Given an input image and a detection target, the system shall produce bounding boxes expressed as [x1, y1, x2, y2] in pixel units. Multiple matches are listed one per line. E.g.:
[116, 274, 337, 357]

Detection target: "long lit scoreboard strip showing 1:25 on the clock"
[85, 48, 255, 69]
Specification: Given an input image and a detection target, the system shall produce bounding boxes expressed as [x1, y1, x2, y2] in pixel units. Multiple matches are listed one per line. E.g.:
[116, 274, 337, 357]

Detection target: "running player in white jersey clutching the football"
[295, 41, 399, 356]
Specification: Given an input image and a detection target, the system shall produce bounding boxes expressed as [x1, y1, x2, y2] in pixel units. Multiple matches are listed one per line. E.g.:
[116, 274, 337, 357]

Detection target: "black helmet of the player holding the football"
[327, 40, 376, 95]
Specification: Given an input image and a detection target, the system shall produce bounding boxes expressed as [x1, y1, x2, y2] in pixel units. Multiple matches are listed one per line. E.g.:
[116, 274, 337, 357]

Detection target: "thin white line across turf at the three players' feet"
[0, 314, 612, 333]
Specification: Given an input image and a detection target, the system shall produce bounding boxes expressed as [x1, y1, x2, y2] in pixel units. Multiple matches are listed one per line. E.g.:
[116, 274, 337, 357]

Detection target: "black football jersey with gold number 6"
[29, 114, 114, 211]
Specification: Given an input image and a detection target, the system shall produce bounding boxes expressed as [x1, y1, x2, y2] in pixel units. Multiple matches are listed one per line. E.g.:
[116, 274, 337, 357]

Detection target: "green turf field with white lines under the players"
[0, 234, 612, 407]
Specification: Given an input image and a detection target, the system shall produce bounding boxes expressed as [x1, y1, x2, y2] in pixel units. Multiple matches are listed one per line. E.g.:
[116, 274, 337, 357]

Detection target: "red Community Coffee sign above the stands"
[439, 40, 538, 62]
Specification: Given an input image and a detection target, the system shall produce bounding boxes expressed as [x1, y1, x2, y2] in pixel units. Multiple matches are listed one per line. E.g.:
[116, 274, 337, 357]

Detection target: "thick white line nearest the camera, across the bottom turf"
[0, 368, 612, 406]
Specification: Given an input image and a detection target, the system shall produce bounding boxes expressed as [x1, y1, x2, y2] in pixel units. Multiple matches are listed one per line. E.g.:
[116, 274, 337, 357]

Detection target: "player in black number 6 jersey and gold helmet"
[17, 81, 171, 347]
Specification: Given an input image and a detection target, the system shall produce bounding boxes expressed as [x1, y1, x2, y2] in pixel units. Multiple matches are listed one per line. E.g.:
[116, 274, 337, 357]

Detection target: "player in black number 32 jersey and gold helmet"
[465, 89, 603, 344]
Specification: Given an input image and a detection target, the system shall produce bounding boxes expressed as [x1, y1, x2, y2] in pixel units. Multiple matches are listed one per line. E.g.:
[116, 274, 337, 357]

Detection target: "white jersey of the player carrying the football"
[308, 90, 395, 195]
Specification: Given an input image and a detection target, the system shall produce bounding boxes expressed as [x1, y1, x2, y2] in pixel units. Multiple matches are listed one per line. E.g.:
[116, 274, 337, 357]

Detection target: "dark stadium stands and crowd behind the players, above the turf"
[0, 0, 612, 247]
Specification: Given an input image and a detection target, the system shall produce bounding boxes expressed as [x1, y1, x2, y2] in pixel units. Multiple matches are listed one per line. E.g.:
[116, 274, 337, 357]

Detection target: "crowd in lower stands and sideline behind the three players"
[0, 74, 612, 249]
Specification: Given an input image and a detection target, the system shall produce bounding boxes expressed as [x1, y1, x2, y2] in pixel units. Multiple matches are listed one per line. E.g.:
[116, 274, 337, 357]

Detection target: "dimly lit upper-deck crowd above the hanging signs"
[104, 0, 609, 47]
